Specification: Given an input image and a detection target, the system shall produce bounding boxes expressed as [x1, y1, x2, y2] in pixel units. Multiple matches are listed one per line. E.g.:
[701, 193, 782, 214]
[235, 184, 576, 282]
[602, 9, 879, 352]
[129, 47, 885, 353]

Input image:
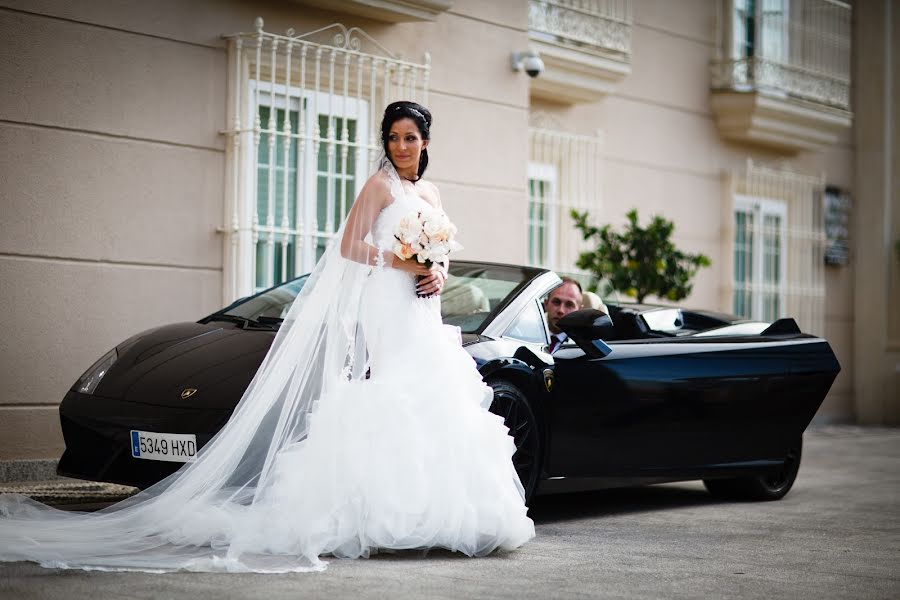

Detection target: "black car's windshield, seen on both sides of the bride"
[217, 261, 541, 333]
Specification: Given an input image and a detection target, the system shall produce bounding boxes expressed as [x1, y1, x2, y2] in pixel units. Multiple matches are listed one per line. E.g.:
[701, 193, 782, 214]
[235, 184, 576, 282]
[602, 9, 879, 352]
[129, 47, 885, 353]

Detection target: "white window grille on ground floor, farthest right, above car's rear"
[722, 161, 825, 335]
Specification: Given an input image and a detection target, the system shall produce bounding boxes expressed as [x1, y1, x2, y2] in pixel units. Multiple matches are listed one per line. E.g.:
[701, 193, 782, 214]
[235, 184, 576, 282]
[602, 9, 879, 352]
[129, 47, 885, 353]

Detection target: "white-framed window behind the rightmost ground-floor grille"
[732, 196, 787, 321]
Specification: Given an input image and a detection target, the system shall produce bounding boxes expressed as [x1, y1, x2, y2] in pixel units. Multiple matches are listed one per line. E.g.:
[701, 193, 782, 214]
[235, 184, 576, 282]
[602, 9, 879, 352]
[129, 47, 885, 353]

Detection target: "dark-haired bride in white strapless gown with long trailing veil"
[0, 102, 534, 572]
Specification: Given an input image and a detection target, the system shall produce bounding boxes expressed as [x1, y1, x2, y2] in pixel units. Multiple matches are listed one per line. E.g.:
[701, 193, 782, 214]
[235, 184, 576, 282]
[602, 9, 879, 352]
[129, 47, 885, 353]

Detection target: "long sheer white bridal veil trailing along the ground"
[0, 160, 412, 572]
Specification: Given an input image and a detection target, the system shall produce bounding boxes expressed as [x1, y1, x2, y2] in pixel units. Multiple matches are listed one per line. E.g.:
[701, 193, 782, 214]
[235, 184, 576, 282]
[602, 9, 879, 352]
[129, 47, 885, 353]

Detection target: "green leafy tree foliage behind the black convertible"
[571, 210, 710, 302]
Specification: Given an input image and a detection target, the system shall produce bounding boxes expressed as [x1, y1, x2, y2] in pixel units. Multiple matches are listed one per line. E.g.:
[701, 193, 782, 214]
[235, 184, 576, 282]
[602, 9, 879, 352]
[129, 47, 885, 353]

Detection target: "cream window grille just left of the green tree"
[527, 113, 603, 273]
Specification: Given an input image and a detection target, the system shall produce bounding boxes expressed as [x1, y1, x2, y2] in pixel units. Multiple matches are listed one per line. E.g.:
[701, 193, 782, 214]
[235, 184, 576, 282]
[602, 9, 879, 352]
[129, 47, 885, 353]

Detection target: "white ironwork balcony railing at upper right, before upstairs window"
[712, 0, 851, 110]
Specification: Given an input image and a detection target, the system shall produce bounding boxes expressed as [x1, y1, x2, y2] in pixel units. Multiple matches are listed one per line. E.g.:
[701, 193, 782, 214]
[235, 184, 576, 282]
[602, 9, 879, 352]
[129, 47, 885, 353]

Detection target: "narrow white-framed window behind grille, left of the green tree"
[528, 163, 557, 266]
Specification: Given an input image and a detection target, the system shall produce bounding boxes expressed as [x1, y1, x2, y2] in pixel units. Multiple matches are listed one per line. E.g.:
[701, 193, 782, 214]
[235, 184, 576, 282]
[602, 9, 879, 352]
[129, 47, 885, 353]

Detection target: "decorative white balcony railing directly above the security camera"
[528, 0, 633, 62]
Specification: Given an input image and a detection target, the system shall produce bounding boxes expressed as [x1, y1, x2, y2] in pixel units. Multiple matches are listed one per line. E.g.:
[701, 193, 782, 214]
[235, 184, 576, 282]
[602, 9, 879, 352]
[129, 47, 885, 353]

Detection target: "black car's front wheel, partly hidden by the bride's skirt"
[487, 379, 543, 503]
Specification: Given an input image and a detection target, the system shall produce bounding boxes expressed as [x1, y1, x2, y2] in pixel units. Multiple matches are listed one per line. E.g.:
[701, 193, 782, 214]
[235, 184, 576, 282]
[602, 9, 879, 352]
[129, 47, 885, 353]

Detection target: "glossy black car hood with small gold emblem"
[95, 322, 275, 410]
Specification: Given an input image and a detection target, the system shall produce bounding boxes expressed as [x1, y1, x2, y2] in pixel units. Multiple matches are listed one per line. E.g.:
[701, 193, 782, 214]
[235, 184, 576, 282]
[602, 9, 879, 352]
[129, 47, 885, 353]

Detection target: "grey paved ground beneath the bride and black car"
[0, 427, 900, 600]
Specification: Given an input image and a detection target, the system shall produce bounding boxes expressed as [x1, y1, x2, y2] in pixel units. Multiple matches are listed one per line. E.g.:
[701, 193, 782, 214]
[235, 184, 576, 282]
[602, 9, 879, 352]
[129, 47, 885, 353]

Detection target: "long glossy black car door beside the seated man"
[550, 336, 833, 476]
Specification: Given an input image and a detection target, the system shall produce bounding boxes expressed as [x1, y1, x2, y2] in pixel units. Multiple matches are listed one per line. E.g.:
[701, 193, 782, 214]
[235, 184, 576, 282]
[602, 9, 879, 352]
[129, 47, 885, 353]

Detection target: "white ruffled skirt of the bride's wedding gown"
[232, 270, 534, 558]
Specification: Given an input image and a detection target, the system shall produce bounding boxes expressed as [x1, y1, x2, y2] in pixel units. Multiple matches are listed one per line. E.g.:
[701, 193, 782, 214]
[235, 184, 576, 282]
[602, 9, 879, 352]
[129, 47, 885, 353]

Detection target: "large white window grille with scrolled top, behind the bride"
[223, 19, 430, 302]
